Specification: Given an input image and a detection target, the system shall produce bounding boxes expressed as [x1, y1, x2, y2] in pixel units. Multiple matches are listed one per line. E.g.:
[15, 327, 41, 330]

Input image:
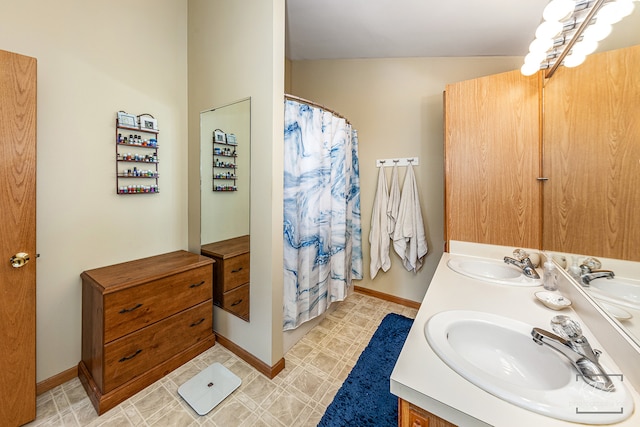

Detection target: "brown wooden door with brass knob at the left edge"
[0, 50, 36, 426]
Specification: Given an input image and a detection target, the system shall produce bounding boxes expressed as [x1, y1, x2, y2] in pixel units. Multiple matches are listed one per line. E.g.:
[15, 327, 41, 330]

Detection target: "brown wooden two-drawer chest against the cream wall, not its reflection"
[78, 251, 215, 414]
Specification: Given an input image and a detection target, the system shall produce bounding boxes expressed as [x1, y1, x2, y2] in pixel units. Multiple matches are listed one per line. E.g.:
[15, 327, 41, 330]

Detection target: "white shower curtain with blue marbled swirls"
[283, 99, 362, 331]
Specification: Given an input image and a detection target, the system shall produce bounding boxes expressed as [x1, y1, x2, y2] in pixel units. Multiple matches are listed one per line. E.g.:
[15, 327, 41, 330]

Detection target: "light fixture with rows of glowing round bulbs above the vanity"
[520, 0, 638, 78]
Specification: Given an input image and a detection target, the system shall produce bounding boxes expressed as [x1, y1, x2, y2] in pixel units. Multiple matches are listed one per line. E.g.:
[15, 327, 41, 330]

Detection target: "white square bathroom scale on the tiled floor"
[178, 363, 242, 415]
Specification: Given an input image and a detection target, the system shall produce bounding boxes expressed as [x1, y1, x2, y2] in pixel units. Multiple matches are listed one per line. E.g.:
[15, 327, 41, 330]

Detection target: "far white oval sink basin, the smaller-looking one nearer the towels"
[447, 256, 542, 286]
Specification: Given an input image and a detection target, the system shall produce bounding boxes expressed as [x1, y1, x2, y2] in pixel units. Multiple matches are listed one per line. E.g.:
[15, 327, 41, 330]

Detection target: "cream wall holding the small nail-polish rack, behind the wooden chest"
[0, 0, 187, 381]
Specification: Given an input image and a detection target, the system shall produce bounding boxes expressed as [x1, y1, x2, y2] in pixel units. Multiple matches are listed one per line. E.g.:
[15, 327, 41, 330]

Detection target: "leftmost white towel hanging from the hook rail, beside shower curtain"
[369, 166, 391, 279]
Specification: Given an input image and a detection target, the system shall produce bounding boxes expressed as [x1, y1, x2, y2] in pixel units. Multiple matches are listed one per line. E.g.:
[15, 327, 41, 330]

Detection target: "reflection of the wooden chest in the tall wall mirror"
[201, 236, 250, 322]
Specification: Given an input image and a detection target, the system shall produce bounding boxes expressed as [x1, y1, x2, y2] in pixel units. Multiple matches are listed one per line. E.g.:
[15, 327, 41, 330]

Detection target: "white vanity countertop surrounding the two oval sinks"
[391, 247, 640, 427]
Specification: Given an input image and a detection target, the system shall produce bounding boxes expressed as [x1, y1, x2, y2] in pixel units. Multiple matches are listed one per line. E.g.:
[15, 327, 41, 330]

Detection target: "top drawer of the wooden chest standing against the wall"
[104, 265, 213, 343]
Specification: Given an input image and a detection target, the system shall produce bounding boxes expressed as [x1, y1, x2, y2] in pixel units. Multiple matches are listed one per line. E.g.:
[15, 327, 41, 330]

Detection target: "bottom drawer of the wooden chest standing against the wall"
[102, 300, 213, 394]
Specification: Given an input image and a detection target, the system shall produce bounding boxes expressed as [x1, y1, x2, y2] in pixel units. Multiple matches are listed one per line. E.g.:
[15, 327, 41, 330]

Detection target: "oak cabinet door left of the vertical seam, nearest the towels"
[445, 71, 542, 248]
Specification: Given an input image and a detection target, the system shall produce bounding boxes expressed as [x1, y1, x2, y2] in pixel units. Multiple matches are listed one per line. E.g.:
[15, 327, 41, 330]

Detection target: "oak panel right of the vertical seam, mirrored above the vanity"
[543, 46, 640, 261]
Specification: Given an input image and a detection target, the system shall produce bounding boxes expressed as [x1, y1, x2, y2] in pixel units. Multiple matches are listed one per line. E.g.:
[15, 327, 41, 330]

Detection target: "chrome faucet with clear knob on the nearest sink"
[531, 315, 615, 391]
